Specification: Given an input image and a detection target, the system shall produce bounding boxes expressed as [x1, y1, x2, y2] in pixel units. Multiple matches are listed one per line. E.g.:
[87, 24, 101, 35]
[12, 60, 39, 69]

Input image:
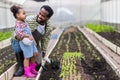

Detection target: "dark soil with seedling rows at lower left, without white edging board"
[0, 46, 16, 74]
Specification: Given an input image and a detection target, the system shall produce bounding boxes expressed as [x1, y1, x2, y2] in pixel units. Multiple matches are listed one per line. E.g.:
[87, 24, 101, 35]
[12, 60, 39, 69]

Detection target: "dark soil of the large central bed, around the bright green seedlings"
[39, 27, 120, 80]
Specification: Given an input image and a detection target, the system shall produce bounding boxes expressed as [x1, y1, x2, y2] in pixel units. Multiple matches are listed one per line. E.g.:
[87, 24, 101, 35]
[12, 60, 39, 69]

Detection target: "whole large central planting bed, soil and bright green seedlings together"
[40, 27, 119, 80]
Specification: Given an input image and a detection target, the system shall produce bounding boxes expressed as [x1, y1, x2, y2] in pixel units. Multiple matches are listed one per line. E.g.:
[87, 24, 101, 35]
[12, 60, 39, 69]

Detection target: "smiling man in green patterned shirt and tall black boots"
[14, 5, 54, 76]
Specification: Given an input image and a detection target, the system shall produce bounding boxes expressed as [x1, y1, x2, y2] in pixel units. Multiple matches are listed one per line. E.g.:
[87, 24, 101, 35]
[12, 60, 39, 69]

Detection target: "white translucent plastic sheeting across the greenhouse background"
[0, 0, 120, 28]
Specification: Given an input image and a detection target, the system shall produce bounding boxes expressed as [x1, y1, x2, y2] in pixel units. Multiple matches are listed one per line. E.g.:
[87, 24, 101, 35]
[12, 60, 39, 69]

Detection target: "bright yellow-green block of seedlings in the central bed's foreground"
[60, 52, 84, 77]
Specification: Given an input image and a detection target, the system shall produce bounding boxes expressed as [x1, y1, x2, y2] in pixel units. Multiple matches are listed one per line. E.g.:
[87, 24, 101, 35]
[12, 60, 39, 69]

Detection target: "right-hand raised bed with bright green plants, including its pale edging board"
[86, 24, 120, 55]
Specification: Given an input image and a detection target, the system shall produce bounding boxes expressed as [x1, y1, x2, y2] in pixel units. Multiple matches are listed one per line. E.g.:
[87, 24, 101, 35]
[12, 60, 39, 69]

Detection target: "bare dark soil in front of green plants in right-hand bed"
[98, 32, 120, 47]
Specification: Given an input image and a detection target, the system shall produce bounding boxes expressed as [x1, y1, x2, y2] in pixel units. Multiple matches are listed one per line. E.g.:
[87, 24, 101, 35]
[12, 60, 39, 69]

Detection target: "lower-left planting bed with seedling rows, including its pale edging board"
[0, 46, 16, 80]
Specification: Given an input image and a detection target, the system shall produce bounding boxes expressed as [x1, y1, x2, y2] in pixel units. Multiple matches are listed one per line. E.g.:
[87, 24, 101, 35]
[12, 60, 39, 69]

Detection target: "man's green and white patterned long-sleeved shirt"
[26, 15, 53, 52]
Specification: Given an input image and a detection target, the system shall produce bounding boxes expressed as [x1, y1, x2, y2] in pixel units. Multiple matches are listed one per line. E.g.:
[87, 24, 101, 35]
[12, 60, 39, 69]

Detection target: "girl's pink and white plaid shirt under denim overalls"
[15, 21, 27, 38]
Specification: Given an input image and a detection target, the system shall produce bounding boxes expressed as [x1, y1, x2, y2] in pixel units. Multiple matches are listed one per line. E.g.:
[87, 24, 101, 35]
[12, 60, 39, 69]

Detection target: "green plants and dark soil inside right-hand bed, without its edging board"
[86, 24, 120, 47]
